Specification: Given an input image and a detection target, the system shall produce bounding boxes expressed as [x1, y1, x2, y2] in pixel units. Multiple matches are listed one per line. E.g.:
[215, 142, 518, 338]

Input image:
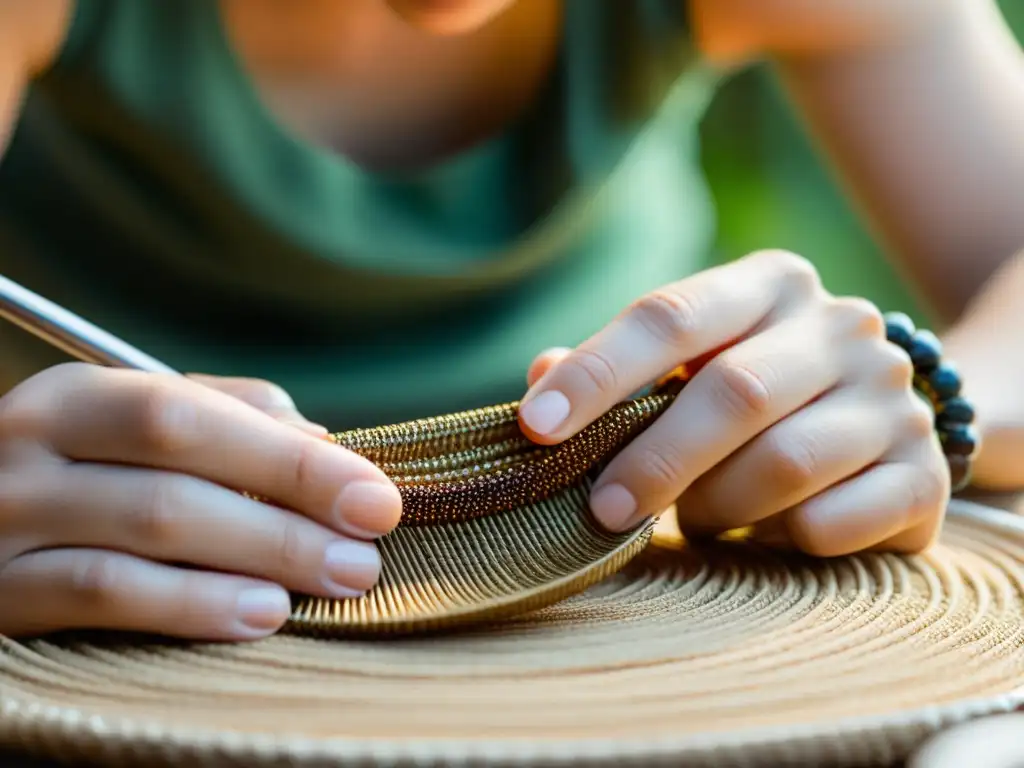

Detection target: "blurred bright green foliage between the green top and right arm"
[702, 0, 1024, 318]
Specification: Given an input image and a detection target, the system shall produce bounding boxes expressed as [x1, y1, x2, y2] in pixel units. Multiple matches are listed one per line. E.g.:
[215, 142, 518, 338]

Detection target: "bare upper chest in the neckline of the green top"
[219, 0, 562, 170]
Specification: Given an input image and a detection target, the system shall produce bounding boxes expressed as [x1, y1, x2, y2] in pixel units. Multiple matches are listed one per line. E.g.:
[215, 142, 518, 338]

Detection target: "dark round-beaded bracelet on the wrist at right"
[885, 312, 978, 494]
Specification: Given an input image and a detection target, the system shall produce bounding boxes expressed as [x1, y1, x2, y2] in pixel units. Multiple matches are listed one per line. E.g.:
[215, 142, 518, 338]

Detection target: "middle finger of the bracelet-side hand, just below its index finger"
[591, 317, 842, 530]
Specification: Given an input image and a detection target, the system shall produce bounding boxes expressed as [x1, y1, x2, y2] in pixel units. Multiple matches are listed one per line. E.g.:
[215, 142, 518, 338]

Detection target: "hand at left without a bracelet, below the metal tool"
[0, 364, 401, 640]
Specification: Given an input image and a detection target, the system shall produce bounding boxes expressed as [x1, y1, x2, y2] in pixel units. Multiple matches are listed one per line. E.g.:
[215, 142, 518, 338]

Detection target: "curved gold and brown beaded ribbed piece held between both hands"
[286, 371, 685, 636]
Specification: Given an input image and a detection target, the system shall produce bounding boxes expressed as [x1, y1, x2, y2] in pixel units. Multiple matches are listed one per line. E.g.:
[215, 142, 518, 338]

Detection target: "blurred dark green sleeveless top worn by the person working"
[0, 0, 716, 428]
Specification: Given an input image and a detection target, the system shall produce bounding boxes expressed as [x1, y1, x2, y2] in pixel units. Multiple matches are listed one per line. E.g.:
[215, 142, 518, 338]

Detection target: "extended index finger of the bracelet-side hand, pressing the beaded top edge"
[519, 254, 818, 442]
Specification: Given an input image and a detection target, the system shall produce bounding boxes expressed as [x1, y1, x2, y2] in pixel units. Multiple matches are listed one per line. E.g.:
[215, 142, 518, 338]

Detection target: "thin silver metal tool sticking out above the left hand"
[0, 274, 178, 374]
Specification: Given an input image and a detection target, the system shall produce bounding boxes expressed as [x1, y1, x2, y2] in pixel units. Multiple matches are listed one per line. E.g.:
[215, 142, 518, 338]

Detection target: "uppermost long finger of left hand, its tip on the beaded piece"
[10, 367, 401, 538]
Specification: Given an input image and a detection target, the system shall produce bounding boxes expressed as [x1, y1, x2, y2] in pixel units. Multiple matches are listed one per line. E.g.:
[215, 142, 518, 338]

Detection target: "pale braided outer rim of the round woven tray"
[0, 501, 1024, 768]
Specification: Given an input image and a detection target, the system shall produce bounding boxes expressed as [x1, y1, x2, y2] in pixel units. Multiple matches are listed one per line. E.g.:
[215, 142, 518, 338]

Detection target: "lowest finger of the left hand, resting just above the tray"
[0, 549, 291, 641]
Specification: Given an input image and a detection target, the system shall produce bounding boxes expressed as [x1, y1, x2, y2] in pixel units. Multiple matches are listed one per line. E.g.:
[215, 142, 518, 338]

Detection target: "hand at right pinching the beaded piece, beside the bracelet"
[520, 252, 950, 556]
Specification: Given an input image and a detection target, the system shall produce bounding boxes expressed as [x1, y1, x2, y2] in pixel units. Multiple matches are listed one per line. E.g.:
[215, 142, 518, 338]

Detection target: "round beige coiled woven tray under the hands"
[0, 503, 1024, 767]
